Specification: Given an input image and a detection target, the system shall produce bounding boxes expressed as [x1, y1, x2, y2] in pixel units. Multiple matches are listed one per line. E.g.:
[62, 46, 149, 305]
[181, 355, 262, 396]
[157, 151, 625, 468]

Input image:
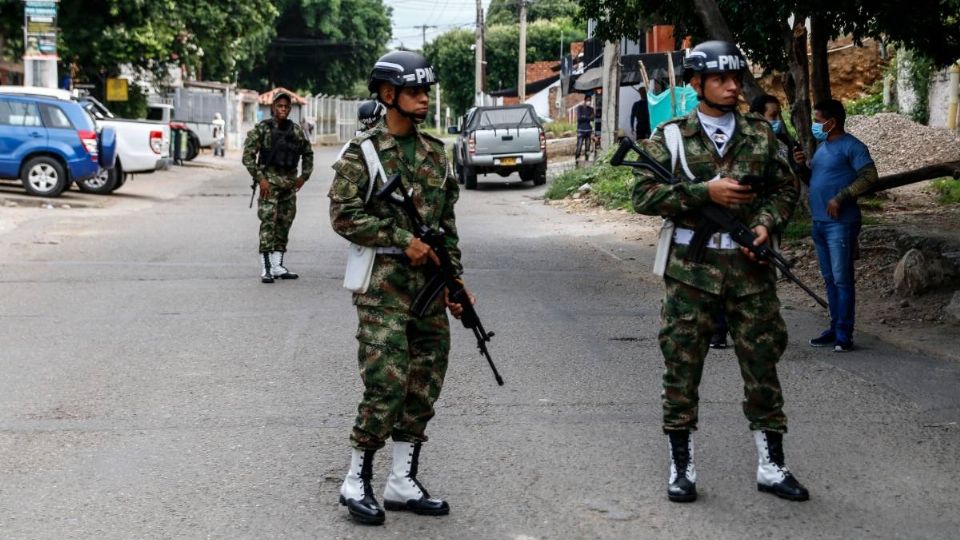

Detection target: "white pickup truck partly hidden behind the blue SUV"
[80, 96, 173, 193]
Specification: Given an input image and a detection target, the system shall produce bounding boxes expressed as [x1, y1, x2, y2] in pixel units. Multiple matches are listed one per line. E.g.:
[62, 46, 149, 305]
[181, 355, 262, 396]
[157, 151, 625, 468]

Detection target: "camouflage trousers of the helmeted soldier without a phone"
[350, 306, 450, 449]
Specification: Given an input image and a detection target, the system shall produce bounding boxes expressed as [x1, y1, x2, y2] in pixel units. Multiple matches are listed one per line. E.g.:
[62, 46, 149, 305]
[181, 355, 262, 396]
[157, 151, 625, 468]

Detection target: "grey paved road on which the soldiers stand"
[0, 149, 960, 539]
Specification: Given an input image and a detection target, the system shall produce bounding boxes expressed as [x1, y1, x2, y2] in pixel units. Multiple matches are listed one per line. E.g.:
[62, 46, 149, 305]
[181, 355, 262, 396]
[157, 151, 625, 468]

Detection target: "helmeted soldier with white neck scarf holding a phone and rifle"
[633, 41, 809, 502]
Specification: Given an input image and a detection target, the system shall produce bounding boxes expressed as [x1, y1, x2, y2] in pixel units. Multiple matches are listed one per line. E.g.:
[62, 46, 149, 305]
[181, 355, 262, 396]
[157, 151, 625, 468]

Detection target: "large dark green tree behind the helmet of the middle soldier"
[240, 0, 391, 94]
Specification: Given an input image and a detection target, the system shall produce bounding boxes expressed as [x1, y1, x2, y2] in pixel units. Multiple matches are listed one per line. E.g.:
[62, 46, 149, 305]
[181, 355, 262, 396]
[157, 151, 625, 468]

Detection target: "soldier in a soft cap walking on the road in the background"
[243, 92, 313, 283]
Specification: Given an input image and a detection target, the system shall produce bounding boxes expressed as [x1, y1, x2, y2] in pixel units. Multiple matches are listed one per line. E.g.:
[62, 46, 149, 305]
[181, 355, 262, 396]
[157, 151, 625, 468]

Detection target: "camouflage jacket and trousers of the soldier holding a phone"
[633, 110, 799, 433]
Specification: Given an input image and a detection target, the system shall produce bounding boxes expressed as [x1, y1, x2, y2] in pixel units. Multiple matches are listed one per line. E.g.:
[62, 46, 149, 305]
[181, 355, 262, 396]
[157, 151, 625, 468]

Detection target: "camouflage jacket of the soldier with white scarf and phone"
[633, 110, 799, 296]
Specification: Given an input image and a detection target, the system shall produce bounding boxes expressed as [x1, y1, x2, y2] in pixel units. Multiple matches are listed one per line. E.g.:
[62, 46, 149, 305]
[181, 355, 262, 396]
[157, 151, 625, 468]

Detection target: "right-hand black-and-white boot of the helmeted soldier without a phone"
[383, 441, 450, 516]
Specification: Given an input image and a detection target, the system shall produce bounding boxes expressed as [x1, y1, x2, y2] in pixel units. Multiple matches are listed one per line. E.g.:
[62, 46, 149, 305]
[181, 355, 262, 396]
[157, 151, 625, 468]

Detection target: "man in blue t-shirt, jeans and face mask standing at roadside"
[793, 99, 877, 352]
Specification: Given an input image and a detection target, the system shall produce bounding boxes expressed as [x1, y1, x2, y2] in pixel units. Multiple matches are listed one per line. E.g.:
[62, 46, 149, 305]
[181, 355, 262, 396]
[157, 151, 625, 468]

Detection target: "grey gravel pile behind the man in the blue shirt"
[846, 113, 960, 176]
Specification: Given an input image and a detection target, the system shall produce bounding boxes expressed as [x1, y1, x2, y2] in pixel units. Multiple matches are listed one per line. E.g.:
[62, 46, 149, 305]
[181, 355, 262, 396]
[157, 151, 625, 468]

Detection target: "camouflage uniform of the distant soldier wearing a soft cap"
[243, 118, 313, 253]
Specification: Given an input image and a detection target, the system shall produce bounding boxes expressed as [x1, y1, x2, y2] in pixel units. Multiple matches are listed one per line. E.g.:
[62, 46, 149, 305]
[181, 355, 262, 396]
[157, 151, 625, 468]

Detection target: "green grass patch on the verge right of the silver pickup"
[545, 149, 634, 210]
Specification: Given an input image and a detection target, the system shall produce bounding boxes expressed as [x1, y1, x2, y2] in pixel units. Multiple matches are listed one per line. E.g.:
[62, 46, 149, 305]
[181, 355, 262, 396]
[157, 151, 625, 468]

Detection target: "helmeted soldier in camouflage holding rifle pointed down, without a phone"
[329, 51, 462, 524]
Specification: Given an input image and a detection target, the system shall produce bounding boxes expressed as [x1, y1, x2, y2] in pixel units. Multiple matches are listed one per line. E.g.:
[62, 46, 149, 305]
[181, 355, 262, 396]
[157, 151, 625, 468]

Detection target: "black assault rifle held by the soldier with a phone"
[610, 137, 829, 308]
